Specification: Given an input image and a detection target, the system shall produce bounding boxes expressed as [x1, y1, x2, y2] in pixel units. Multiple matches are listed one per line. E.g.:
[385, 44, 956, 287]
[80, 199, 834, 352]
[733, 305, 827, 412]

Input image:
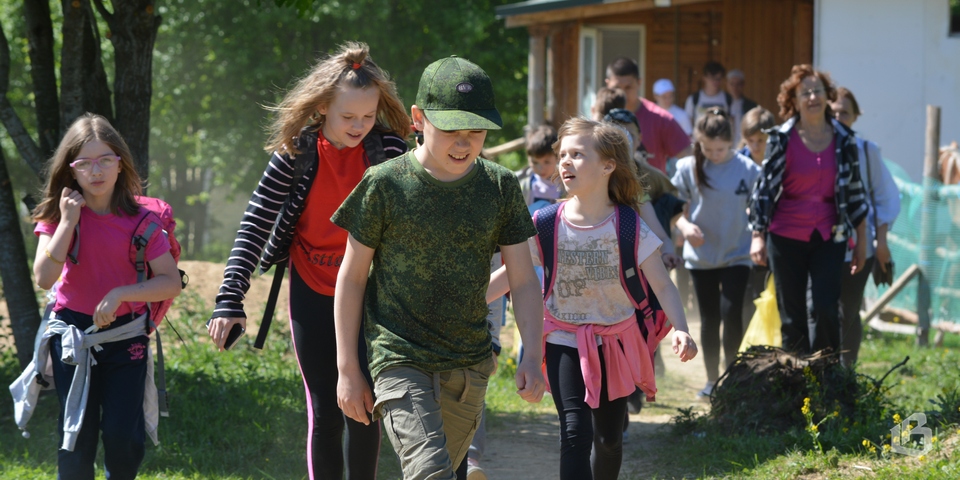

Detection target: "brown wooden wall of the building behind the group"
[531, 0, 813, 124]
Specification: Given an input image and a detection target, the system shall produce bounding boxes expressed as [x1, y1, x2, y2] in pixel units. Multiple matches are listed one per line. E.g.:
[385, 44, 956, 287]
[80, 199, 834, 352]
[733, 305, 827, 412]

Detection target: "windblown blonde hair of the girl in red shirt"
[264, 42, 411, 154]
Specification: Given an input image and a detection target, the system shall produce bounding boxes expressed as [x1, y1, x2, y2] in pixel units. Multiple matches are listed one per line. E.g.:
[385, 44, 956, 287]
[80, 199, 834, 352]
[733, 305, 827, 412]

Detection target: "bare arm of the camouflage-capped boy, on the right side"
[498, 242, 546, 403]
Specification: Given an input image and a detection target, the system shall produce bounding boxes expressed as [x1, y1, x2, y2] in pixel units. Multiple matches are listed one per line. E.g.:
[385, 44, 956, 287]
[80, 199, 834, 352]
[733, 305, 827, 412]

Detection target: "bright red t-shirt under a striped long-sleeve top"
[290, 133, 367, 296]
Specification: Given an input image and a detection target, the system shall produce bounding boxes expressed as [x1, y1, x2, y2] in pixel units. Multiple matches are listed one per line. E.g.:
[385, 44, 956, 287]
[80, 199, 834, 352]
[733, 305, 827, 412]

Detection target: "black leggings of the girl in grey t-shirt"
[690, 265, 750, 382]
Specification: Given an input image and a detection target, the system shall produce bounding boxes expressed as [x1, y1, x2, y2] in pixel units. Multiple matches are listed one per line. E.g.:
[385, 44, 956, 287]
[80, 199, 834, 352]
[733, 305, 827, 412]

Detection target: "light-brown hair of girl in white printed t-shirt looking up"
[554, 117, 643, 212]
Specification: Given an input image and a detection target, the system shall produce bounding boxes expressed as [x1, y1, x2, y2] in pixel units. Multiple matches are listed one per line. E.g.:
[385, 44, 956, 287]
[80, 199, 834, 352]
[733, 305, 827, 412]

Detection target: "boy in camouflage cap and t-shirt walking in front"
[331, 57, 545, 479]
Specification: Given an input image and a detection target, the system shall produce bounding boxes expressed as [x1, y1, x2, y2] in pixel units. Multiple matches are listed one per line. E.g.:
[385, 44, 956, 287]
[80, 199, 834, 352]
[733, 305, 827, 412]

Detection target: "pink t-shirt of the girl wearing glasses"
[33, 207, 170, 316]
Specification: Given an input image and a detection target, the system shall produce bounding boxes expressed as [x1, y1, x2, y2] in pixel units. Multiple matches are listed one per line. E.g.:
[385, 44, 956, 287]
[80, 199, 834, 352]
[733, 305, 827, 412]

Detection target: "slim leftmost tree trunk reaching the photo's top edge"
[23, 0, 60, 158]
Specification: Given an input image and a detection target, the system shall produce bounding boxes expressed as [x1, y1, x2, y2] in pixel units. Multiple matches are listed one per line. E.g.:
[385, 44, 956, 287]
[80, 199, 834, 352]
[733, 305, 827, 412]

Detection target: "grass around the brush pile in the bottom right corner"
[621, 334, 960, 479]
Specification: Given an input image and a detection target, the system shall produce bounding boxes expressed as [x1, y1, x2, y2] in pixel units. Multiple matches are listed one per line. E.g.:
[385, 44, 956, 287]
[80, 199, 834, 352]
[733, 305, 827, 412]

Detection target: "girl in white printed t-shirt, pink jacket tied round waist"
[487, 118, 697, 480]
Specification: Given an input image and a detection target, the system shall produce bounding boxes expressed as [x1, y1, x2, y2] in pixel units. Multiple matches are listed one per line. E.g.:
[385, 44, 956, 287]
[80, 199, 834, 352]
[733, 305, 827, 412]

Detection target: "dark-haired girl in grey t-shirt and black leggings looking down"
[672, 108, 760, 397]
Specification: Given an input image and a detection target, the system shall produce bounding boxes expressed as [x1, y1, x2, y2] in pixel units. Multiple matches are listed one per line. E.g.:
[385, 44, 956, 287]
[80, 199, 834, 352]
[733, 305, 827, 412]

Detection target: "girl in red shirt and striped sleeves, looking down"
[207, 42, 411, 479]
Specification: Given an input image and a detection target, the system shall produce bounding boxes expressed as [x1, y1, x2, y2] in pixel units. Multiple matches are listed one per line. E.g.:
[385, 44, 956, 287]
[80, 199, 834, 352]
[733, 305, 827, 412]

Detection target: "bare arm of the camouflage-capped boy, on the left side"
[333, 234, 375, 425]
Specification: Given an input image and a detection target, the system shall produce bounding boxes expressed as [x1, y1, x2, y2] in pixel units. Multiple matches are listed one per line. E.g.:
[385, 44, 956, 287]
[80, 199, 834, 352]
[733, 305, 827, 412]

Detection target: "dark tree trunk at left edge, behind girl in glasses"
[0, 149, 40, 367]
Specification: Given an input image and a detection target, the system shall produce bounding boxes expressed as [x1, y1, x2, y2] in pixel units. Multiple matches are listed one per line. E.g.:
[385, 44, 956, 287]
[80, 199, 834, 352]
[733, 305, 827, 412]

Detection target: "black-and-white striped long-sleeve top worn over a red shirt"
[212, 131, 407, 318]
